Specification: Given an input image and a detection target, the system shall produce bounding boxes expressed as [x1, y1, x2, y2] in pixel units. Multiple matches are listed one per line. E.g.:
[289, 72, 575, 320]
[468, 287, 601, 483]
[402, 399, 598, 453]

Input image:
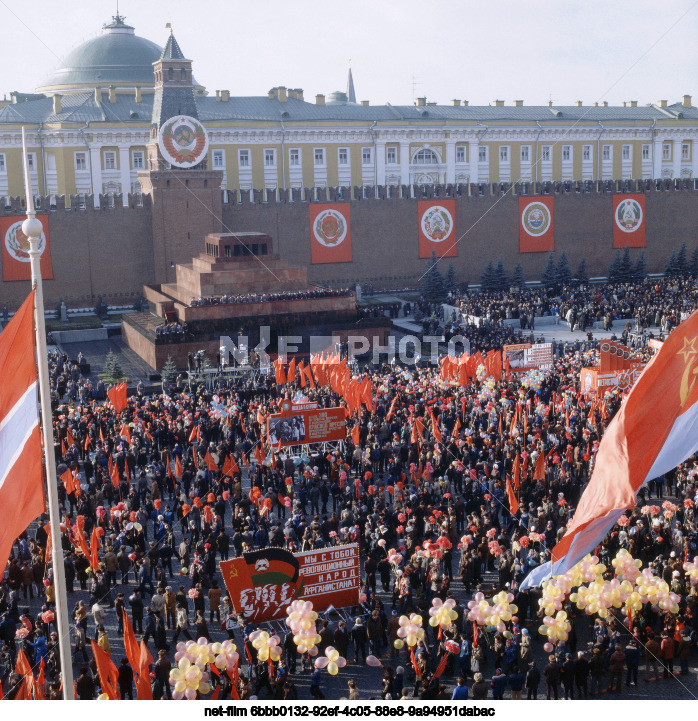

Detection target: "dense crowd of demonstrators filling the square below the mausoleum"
[0, 278, 698, 699]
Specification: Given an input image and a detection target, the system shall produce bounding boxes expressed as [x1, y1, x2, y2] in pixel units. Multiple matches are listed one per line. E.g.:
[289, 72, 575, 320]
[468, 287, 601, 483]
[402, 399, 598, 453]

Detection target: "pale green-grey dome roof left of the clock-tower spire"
[37, 15, 162, 92]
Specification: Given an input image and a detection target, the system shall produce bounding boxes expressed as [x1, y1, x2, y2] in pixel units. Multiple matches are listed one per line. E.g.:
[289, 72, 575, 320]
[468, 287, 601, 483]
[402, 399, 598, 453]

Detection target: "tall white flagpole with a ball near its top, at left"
[22, 128, 75, 701]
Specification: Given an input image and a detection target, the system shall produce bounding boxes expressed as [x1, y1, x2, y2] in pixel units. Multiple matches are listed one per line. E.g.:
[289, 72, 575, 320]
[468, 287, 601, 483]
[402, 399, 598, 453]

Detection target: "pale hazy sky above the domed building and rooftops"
[0, 0, 698, 105]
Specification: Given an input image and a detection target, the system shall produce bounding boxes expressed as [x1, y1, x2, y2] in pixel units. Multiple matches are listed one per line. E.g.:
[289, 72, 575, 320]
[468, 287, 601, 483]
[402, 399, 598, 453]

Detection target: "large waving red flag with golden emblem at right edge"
[521, 311, 698, 588]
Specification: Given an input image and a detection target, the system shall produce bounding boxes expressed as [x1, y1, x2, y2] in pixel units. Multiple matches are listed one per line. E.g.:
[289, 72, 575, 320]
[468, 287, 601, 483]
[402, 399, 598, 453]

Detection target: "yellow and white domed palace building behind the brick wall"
[0, 16, 698, 202]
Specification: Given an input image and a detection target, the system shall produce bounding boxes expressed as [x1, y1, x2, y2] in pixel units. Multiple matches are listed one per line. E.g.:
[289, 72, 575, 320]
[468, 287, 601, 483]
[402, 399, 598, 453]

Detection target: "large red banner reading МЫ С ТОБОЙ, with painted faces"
[220, 543, 361, 623]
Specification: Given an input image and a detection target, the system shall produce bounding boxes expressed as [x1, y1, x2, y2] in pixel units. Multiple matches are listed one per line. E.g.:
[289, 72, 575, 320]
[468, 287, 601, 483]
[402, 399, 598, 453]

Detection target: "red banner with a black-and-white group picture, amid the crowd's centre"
[267, 404, 347, 447]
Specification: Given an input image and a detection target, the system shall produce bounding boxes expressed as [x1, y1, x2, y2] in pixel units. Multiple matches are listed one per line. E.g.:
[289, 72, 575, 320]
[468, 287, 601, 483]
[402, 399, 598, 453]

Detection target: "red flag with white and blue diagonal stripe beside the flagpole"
[0, 291, 45, 573]
